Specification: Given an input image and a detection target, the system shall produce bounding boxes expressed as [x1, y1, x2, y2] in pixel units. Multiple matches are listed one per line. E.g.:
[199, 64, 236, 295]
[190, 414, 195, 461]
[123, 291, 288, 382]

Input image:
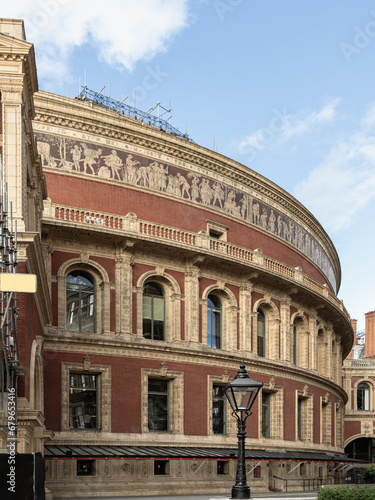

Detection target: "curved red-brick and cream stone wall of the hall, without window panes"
[34, 92, 353, 498]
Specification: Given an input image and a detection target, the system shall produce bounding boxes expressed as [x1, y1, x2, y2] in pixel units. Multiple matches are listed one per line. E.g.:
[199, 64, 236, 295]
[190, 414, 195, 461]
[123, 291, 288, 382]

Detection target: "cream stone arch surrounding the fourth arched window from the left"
[252, 297, 280, 359]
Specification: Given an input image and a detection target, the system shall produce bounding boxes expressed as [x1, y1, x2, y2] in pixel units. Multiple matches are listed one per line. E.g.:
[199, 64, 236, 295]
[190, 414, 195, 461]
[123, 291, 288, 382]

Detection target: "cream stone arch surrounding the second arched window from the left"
[137, 269, 182, 342]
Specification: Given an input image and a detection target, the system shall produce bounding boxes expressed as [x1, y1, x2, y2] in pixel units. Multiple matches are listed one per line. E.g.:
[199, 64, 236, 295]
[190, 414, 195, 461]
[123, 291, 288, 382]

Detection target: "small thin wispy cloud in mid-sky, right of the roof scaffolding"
[239, 99, 340, 157]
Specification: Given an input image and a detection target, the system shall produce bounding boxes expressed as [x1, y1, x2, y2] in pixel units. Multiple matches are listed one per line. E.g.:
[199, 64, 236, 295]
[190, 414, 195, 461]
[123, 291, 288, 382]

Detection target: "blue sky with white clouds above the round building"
[1, 0, 375, 329]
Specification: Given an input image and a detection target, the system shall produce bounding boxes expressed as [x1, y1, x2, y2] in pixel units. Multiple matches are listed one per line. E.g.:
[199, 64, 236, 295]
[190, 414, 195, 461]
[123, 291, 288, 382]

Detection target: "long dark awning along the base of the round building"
[44, 444, 360, 463]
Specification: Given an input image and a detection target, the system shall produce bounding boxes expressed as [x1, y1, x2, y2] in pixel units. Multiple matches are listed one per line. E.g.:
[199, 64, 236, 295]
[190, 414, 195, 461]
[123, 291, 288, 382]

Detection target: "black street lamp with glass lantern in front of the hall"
[224, 362, 263, 498]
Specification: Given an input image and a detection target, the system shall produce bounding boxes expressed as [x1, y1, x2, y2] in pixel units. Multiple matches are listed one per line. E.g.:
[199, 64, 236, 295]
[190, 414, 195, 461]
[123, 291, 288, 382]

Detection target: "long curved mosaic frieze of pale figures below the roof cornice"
[36, 133, 336, 288]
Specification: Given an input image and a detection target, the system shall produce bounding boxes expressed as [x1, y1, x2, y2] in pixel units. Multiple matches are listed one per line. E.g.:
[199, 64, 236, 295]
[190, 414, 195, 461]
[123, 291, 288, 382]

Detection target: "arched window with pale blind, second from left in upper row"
[143, 282, 165, 340]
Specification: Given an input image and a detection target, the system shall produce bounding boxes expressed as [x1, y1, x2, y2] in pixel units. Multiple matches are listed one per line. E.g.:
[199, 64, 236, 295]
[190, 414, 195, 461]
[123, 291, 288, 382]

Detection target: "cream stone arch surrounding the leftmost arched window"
[57, 258, 111, 333]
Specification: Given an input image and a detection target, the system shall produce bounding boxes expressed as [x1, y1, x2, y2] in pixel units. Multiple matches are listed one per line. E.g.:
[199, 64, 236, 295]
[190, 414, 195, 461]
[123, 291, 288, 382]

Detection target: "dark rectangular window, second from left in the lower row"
[148, 378, 169, 432]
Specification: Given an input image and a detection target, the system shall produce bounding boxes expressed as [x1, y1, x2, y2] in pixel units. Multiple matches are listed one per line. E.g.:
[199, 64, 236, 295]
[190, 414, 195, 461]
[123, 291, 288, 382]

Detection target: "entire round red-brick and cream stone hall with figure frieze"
[0, 20, 353, 499]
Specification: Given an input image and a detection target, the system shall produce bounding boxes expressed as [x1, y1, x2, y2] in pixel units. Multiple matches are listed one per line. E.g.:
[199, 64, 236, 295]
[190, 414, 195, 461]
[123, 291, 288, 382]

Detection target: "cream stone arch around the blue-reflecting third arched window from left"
[201, 283, 238, 351]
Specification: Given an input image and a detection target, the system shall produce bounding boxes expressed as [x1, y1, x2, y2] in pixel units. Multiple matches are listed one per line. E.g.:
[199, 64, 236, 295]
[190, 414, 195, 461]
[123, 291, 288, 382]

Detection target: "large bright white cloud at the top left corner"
[1, 0, 188, 86]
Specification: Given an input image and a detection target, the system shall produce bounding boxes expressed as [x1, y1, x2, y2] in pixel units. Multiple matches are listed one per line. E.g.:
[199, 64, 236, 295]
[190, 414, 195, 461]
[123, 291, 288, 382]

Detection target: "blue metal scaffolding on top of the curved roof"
[77, 86, 193, 142]
